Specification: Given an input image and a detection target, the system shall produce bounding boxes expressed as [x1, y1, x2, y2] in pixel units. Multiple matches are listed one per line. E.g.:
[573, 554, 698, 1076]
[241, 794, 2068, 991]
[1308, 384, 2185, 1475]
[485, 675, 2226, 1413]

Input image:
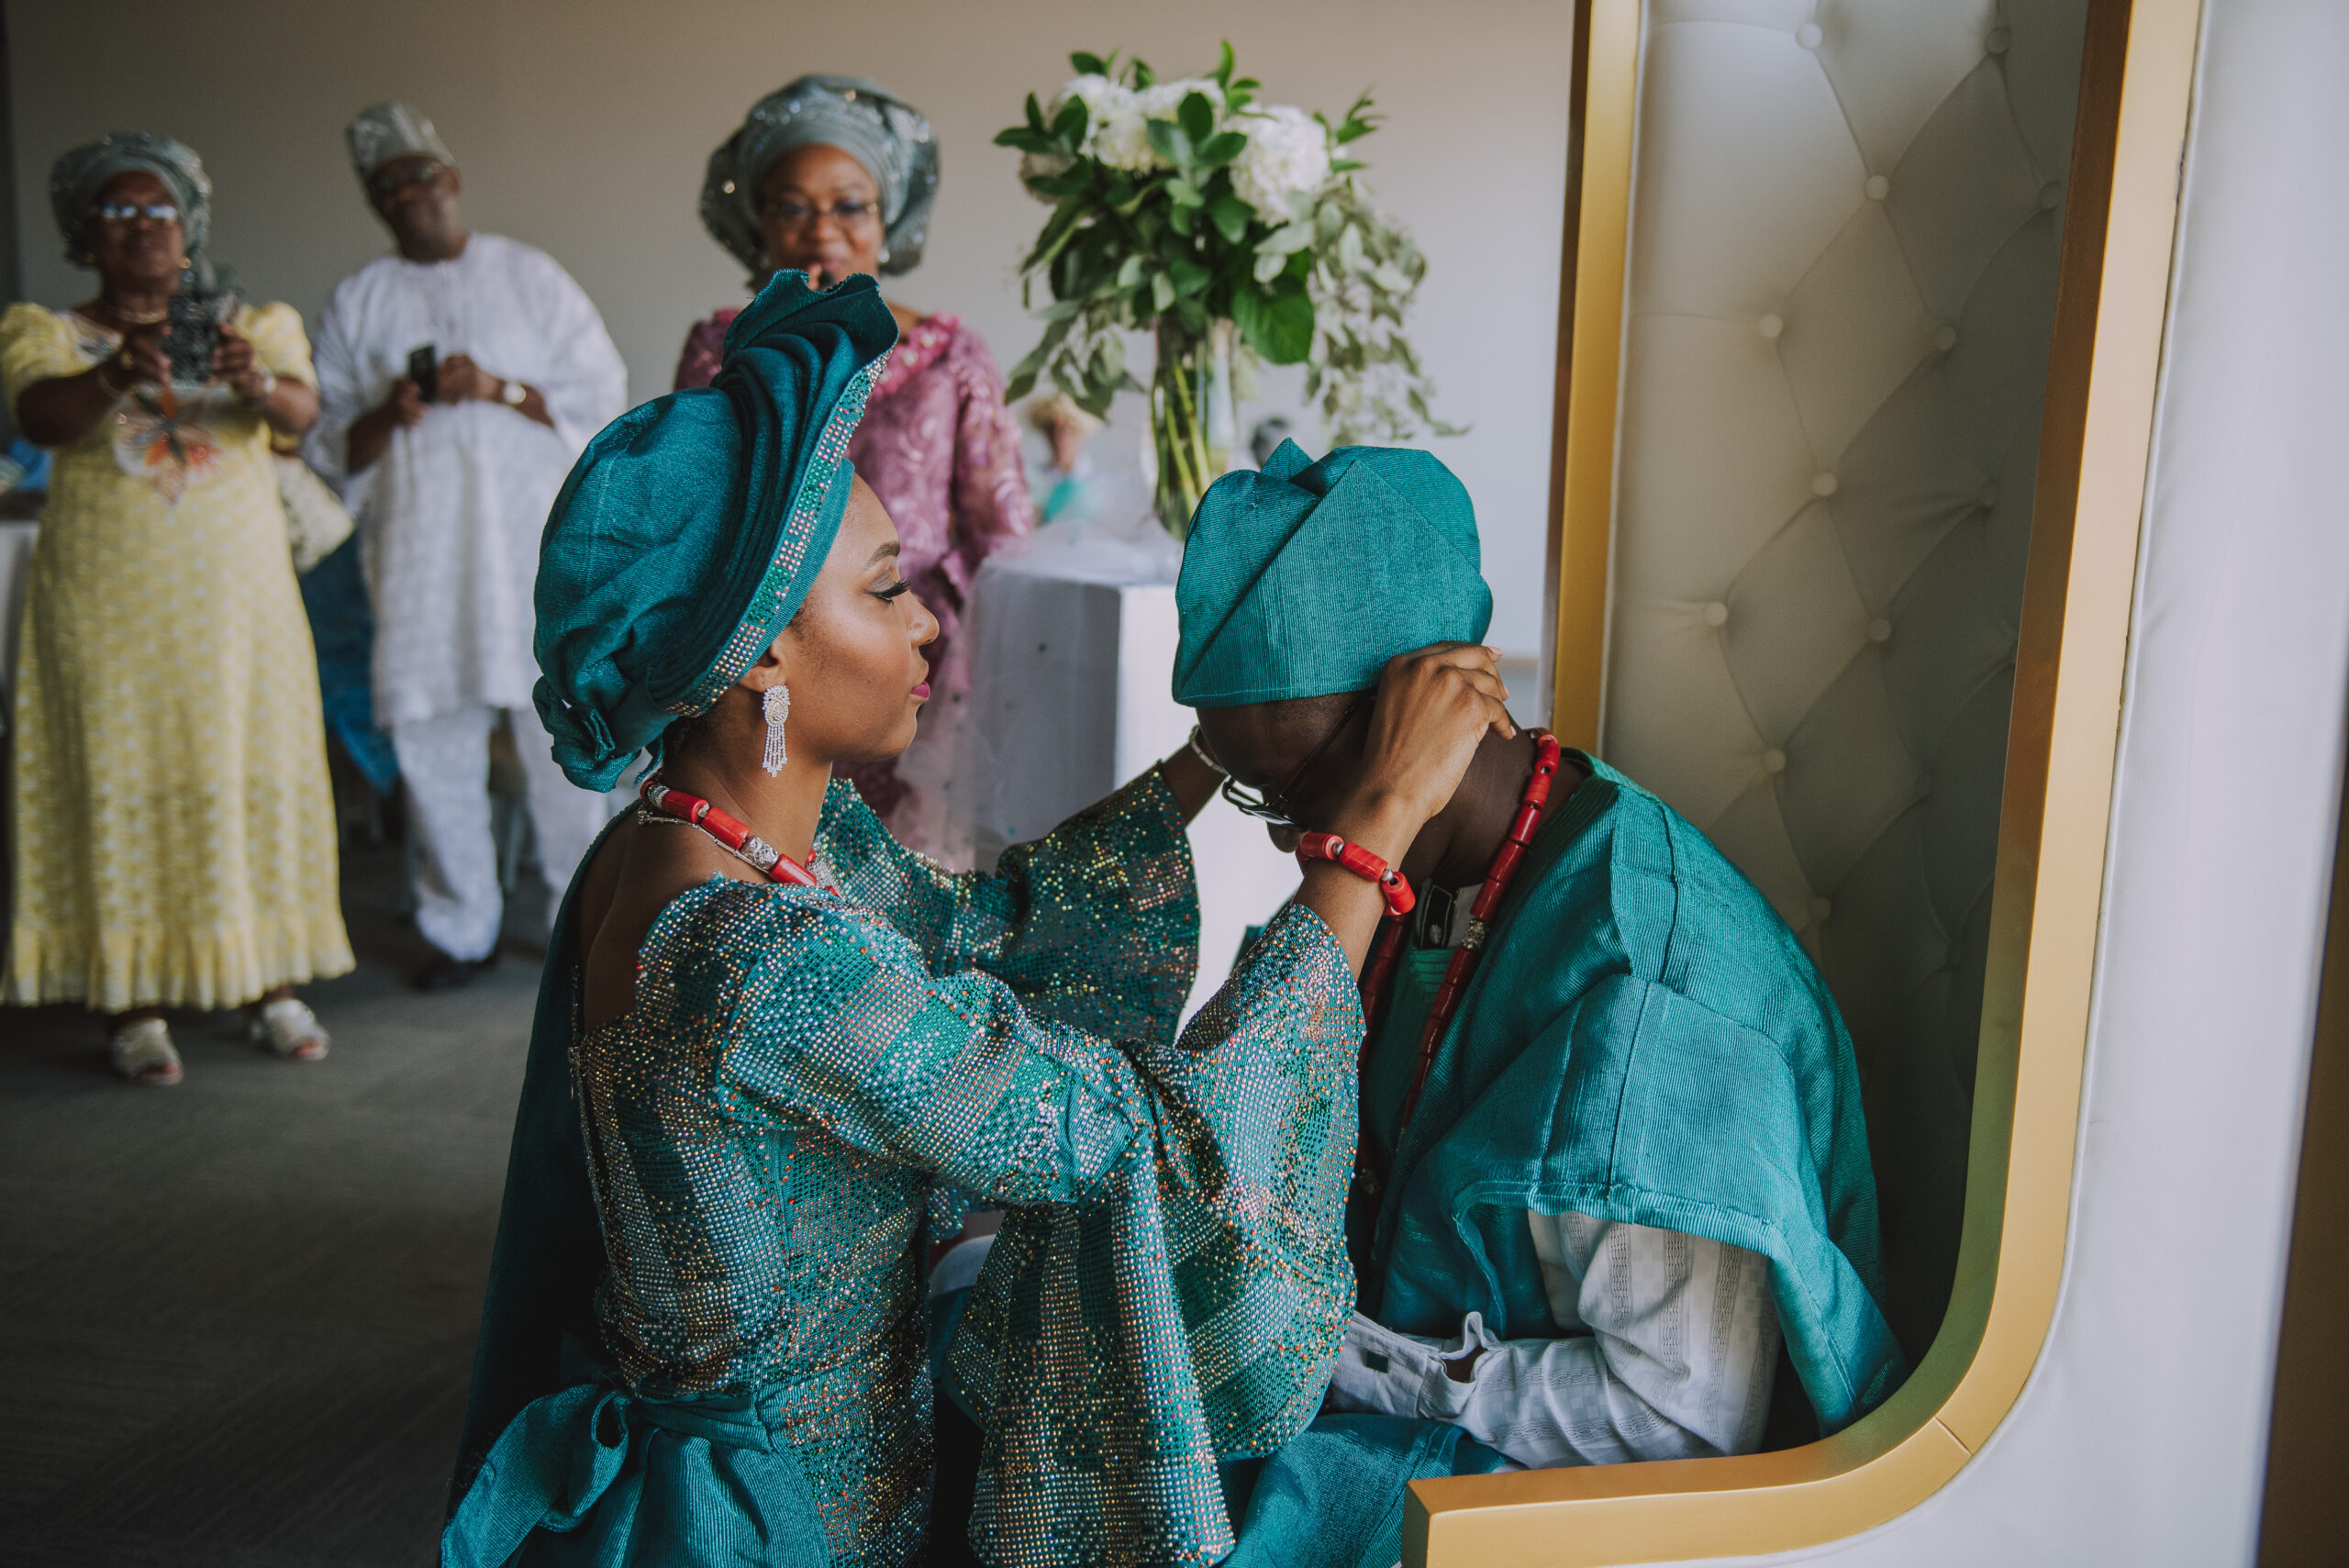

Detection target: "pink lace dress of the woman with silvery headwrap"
[676, 310, 1036, 862]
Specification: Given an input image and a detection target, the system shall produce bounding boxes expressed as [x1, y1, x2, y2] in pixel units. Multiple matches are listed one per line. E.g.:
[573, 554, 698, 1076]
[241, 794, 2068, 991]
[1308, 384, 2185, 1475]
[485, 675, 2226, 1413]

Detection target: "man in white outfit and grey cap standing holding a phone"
[307, 104, 628, 991]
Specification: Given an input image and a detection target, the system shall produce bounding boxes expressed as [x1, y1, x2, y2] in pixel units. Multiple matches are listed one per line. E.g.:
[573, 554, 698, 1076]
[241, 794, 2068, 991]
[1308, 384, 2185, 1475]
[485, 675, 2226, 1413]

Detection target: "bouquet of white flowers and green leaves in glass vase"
[996, 42, 1456, 535]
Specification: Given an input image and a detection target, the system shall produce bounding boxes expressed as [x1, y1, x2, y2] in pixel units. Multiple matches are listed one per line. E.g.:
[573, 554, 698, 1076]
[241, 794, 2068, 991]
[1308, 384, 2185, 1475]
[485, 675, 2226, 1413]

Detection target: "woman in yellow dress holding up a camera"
[0, 134, 352, 1084]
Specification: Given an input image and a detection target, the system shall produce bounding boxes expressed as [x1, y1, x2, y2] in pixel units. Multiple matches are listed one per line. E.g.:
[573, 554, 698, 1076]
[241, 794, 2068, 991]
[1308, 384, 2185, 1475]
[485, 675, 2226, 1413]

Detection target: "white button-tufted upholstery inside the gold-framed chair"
[1602, 0, 2086, 1357]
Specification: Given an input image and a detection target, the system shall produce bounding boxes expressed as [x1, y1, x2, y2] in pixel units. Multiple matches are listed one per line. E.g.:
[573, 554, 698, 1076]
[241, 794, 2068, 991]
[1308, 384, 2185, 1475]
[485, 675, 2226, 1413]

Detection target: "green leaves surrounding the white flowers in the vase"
[996, 42, 1456, 444]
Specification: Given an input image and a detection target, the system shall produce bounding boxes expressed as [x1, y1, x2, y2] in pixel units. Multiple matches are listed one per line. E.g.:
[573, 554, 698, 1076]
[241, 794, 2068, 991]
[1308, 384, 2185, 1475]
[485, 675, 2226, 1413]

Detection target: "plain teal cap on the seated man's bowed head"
[1174, 441, 1492, 709]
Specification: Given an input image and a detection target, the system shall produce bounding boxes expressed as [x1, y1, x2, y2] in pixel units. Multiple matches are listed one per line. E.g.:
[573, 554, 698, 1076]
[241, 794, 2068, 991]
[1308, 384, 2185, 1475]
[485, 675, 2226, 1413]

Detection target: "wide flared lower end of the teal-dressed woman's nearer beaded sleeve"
[947, 904, 1363, 1568]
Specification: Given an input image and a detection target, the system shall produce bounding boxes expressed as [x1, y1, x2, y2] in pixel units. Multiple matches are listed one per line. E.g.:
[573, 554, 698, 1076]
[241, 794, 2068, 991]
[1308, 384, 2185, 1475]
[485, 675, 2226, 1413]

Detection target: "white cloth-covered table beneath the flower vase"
[961, 526, 1299, 1014]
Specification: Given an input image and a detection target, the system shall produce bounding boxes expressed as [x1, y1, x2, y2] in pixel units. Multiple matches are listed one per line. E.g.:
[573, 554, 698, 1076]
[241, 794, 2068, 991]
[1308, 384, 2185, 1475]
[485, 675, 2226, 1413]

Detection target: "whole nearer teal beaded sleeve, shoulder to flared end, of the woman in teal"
[679, 883, 1363, 1565]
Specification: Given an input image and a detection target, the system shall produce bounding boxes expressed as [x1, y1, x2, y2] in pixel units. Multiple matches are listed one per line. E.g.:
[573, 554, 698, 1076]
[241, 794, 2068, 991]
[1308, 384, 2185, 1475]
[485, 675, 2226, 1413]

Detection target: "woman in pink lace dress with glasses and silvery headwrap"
[676, 75, 1036, 862]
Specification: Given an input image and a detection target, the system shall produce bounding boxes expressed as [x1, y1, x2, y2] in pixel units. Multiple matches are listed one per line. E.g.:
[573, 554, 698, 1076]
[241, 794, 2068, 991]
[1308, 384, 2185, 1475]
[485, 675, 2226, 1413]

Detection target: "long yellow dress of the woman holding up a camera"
[0, 306, 350, 1012]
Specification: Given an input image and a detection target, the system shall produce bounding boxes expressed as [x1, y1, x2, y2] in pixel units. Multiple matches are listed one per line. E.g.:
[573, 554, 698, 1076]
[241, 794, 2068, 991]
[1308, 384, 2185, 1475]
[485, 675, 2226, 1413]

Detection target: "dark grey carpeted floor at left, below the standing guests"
[0, 850, 538, 1568]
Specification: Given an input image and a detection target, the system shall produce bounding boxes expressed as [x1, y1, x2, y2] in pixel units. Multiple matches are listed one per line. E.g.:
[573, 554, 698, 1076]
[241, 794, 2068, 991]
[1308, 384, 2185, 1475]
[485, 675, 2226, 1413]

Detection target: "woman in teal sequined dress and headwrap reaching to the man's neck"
[441, 272, 1510, 1568]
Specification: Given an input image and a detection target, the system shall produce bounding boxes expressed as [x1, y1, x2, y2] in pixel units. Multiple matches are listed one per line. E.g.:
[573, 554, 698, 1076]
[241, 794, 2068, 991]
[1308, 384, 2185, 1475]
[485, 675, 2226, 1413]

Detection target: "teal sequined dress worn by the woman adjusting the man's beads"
[444, 773, 1360, 1565]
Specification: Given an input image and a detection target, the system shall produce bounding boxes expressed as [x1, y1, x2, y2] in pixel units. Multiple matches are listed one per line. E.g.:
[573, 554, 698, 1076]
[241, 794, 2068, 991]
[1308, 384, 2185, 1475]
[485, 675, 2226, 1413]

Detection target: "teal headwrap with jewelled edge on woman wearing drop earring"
[531, 272, 897, 789]
